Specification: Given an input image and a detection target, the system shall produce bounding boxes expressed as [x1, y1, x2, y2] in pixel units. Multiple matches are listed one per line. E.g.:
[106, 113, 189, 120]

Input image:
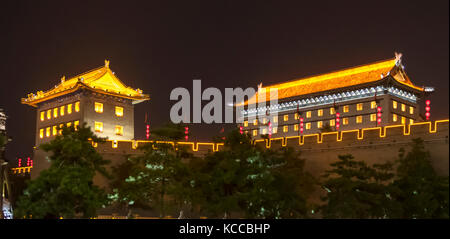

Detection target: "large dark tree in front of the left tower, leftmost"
[16, 124, 109, 218]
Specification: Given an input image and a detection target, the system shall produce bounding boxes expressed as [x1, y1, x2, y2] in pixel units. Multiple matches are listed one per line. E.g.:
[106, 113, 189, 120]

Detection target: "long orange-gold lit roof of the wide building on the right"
[241, 58, 424, 106]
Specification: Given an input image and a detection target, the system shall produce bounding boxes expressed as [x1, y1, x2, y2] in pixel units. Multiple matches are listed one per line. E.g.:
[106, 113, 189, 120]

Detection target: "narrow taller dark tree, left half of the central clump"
[194, 130, 256, 217]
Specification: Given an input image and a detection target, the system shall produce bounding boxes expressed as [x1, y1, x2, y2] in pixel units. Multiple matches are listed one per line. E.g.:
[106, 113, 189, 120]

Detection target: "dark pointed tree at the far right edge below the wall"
[393, 138, 449, 218]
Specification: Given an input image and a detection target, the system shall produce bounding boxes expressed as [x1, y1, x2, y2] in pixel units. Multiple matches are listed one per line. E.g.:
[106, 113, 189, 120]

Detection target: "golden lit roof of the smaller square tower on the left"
[22, 60, 150, 107]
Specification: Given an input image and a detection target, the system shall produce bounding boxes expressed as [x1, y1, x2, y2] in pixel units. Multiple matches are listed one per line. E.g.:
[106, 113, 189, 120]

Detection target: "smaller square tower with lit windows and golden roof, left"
[22, 60, 149, 178]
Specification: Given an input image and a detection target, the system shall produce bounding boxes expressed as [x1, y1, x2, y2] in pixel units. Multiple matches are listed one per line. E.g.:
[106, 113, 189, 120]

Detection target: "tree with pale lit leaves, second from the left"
[110, 124, 192, 217]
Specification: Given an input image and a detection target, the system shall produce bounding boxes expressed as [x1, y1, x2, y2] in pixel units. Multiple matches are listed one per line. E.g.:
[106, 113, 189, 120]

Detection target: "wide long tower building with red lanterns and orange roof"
[237, 53, 434, 138]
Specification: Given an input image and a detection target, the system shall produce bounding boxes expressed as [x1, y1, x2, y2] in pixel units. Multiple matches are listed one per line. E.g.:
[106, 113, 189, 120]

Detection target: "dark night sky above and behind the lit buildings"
[0, 0, 449, 162]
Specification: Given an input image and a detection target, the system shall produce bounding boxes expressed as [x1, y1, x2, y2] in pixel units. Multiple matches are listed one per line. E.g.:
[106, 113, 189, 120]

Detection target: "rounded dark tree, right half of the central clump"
[244, 148, 315, 218]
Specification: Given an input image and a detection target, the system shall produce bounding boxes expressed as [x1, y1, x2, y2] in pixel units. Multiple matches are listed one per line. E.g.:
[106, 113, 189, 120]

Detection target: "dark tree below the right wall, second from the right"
[321, 154, 399, 218]
